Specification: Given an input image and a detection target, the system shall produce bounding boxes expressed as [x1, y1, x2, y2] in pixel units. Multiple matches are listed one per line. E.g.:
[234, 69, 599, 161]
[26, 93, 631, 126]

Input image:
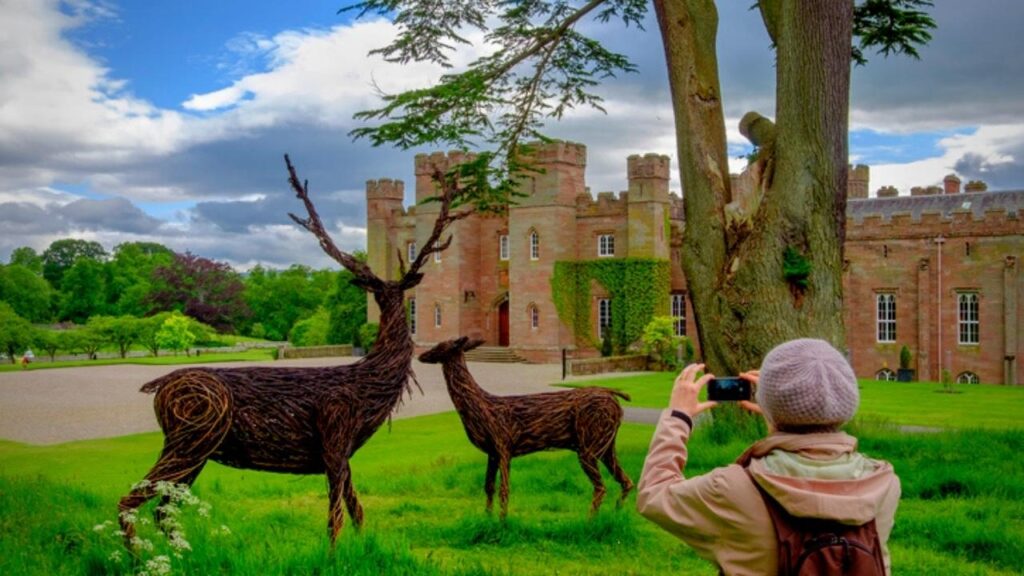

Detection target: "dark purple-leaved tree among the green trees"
[147, 252, 250, 332]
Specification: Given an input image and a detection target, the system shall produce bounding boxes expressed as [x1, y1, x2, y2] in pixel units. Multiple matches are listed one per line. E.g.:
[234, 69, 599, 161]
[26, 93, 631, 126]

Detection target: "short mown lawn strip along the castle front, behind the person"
[565, 372, 1024, 429]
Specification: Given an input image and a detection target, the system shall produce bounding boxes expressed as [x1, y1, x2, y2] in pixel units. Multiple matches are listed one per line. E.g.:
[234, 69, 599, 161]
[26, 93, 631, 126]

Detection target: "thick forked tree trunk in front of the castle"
[654, 0, 853, 374]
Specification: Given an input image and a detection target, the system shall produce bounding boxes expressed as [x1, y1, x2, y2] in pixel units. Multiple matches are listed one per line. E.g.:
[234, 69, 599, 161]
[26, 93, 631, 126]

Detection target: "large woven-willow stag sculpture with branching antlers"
[119, 156, 469, 543]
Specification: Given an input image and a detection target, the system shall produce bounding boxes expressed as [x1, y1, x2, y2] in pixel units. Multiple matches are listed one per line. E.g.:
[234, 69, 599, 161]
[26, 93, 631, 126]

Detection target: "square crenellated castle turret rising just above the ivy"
[626, 154, 670, 258]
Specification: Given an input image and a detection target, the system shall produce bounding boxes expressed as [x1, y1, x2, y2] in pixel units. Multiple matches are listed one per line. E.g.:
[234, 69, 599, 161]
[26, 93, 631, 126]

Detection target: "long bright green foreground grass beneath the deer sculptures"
[0, 413, 1024, 576]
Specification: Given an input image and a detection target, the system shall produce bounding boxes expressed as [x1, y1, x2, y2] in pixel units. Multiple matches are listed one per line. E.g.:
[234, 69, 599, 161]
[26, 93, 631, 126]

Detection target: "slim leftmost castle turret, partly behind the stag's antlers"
[367, 178, 406, 322]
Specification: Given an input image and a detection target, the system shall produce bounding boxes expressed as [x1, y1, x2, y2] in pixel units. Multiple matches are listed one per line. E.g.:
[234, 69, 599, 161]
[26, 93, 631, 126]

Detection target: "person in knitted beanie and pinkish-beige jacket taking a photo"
[637, 338, 900, 575]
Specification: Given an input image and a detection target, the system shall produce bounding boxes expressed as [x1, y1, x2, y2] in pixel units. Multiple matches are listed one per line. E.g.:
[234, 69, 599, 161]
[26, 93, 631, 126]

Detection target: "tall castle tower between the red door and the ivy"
[507, 141, 587, 357]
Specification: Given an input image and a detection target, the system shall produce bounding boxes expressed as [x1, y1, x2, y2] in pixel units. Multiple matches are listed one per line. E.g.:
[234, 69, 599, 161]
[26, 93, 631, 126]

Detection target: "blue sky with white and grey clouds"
[0, 0, 1024, 270]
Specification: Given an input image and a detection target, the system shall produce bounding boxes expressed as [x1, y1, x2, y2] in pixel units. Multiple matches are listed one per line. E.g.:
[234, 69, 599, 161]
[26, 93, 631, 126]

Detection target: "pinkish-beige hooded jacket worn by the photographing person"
[637, 410, 900, 575]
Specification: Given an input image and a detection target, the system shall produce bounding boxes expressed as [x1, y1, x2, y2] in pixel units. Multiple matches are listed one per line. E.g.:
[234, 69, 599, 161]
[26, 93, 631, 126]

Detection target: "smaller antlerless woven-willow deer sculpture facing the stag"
[420, 337, 633, 512]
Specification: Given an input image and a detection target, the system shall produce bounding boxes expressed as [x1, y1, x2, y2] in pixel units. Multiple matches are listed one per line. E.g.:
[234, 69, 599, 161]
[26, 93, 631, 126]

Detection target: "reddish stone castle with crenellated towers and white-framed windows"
[367, 141, 1024, 384]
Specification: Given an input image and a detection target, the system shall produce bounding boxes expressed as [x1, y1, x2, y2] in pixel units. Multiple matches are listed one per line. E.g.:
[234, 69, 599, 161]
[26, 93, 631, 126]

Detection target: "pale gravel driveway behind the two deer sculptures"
[0, 358, 638, 444]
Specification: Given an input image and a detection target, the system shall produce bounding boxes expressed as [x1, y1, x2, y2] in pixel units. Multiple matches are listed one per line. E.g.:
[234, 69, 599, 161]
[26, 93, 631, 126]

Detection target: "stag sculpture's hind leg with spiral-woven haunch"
[118, 372, 231, 545]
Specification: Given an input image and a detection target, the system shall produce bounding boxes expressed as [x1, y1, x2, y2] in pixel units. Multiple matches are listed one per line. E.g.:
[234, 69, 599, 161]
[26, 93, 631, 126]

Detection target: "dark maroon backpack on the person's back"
[743, 467, 886, 576]
